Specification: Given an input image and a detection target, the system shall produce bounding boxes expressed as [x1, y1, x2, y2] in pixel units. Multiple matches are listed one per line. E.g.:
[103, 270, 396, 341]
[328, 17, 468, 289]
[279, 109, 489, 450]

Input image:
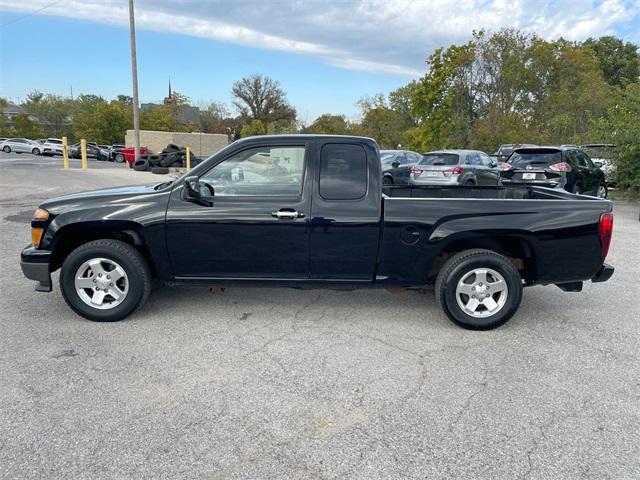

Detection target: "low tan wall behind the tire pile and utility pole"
[125, 130, 229, 158]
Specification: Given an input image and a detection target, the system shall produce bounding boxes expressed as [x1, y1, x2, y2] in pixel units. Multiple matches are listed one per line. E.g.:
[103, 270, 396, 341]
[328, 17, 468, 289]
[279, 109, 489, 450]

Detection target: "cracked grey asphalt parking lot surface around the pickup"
[0, 153, 640, 479]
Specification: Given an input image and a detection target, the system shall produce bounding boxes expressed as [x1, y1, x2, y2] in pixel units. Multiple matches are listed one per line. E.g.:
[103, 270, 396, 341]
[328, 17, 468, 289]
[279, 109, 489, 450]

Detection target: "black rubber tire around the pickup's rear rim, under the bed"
[436, 249, 522, 330]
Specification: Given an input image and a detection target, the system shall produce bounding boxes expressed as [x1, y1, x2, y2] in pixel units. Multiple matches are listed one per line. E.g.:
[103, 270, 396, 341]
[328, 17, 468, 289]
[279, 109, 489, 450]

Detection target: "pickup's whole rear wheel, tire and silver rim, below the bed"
[436, 249, 522, 330]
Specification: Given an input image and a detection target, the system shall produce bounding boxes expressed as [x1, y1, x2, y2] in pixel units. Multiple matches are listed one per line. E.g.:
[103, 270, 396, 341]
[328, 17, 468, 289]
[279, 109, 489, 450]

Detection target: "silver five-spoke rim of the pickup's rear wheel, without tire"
[456, 268, 509, 318]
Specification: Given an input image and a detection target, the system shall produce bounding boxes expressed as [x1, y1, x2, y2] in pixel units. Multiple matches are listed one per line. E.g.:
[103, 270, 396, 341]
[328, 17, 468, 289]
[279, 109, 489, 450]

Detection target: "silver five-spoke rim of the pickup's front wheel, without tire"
[74, 258, 129, 310]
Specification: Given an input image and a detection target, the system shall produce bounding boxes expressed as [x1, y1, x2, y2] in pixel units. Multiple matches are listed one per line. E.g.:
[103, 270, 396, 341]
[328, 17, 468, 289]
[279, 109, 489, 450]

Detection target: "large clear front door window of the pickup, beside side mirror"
[200, 146, 305, 197]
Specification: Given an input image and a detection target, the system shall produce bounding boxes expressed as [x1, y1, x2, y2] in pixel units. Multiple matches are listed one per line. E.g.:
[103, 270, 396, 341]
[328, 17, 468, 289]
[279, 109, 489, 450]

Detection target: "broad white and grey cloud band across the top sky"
[0, 0, 640, 77]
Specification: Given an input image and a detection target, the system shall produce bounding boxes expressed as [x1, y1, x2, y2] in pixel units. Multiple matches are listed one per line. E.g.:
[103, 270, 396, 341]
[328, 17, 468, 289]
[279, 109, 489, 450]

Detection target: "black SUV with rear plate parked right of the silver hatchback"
[500, 146, 608, 198]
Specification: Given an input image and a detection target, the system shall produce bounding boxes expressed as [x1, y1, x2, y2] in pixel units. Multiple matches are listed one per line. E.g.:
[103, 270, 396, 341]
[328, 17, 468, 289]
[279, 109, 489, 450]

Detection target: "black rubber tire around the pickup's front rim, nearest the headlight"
[60, 239, 151, 322]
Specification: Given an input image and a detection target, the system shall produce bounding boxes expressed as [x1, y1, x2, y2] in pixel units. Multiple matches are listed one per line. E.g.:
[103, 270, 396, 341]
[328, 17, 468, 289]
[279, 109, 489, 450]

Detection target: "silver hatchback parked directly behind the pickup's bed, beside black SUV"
[409, 150, 500, 186]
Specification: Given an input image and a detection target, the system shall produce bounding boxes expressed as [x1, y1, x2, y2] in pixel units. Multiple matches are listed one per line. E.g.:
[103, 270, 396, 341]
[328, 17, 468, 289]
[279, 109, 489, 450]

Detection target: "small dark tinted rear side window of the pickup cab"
[320, 143, 368, 200]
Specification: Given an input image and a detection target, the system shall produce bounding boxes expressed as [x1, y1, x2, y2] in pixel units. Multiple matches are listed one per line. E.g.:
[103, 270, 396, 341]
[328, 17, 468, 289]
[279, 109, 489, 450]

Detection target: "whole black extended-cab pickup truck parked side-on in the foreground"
[21, 135, 613, 330]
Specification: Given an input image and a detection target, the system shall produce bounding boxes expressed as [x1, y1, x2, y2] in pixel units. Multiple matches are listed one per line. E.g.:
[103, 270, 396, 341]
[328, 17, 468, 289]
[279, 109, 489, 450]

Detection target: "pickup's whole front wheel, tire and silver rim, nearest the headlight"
[60, 239, 151, 322]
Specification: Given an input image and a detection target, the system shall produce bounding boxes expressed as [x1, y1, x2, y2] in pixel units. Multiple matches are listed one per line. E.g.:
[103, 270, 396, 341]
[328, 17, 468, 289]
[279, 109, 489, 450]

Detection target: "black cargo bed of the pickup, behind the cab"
[377, 185, 612, 284]
